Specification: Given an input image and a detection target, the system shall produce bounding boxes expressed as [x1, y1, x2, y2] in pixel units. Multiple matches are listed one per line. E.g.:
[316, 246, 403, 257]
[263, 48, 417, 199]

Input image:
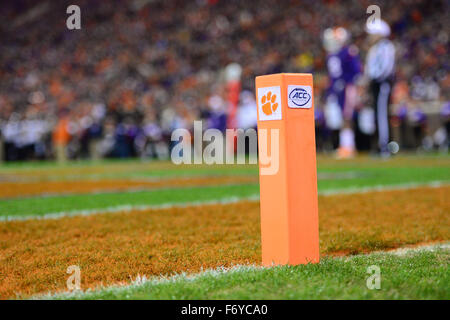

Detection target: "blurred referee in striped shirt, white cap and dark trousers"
[365, 19, 395, 156]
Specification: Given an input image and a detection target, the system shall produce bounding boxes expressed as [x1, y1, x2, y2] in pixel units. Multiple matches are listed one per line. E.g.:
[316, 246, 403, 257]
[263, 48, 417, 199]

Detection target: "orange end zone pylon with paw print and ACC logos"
[256, 73, 319, 265]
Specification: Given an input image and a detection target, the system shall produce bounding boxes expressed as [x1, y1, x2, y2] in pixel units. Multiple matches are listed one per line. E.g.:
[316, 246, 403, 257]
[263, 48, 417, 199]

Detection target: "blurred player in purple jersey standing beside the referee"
[323, 27, 361, 158]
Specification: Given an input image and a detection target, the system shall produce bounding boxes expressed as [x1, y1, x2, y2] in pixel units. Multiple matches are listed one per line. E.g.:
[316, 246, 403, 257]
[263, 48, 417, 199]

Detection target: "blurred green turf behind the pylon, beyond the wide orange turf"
[0, 157, 450, 218]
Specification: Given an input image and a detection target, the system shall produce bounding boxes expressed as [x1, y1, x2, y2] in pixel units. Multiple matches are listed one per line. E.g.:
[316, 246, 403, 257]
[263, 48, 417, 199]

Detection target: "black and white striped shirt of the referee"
[366, 39, 395, 81]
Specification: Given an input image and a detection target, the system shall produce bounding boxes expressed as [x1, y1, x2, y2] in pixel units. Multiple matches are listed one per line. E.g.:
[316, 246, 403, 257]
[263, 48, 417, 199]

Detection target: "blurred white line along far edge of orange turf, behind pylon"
[0, 181, 450, 222]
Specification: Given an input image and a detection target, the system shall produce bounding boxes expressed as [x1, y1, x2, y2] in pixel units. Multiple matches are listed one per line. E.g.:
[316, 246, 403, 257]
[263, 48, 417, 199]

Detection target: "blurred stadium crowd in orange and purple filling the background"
[0, 0, 450, 160]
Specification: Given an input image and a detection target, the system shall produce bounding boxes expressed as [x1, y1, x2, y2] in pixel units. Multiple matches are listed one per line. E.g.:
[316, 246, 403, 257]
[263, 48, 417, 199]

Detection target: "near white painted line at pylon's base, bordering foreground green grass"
[36, 242, 450, 299]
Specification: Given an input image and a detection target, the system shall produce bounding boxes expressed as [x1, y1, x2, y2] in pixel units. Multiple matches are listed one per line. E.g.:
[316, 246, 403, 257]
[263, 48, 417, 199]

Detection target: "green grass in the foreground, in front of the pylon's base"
[49, 247, 450, 300]
